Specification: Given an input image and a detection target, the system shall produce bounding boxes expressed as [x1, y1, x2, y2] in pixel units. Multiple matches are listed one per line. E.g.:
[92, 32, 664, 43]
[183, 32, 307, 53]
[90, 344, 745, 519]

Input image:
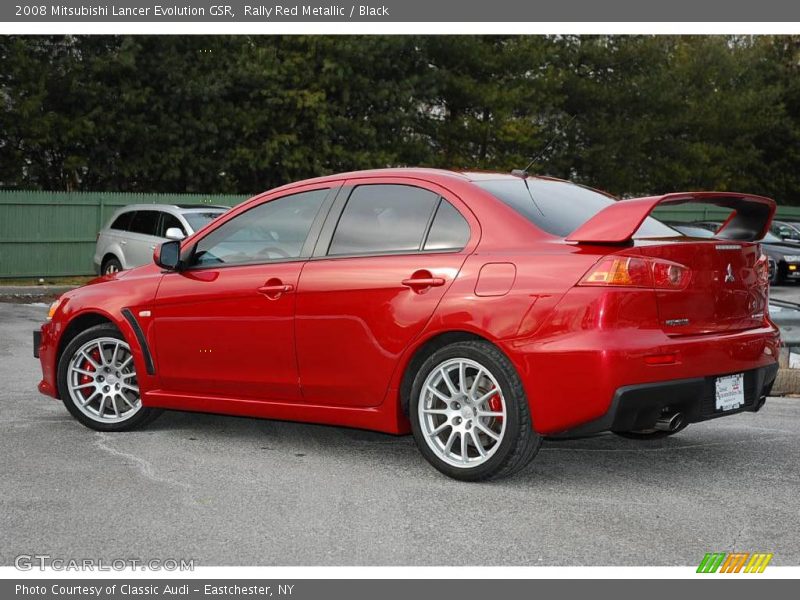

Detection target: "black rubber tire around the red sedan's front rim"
[57, 324, 163, 431]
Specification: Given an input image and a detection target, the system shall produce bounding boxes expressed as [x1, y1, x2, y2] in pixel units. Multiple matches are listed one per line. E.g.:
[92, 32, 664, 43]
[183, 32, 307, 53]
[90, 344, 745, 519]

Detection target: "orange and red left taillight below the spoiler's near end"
[578, 256, 692, 290]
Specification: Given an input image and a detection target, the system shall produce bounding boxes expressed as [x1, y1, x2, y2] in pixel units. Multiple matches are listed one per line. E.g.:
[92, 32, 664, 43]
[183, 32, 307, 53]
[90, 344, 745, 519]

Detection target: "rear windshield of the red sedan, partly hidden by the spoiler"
[474, 178, 679, 238]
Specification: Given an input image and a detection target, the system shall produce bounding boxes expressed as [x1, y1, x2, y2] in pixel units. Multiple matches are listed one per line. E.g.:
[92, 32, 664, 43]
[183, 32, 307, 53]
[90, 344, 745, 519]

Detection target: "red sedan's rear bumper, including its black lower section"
[501, 323, 780, 435]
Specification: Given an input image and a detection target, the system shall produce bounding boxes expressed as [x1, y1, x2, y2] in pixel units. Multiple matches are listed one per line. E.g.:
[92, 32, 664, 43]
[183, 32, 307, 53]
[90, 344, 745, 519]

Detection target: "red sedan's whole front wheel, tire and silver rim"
[58, 324, 161, 431]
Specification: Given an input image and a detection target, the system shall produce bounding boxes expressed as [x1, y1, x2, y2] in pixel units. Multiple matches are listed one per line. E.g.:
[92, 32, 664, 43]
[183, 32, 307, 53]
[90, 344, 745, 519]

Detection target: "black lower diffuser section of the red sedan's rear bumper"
[564, 363, 778, 436]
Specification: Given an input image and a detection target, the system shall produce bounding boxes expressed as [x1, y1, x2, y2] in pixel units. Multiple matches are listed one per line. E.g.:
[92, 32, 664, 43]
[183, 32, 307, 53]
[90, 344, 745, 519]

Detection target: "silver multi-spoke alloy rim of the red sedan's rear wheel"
[417, 358, 507, 468]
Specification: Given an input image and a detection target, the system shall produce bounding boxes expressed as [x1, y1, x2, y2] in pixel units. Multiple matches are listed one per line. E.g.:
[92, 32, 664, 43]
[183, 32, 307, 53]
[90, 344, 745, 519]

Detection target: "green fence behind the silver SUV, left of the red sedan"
[0, 191, 246, 278]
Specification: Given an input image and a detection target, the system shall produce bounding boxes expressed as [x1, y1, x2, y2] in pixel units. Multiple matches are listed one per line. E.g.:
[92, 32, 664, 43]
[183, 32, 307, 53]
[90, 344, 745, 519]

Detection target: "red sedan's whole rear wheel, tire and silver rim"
[409, 341, 542, 481]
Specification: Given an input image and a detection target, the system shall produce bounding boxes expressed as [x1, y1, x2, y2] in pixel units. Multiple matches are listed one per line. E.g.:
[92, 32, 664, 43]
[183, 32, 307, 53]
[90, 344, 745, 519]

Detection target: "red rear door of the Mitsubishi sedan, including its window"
[296, 179, 477, 406]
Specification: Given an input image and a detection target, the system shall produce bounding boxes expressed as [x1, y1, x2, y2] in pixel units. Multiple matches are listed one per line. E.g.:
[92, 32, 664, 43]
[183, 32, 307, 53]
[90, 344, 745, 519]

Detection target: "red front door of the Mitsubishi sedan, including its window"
[153, 187, 333, 401]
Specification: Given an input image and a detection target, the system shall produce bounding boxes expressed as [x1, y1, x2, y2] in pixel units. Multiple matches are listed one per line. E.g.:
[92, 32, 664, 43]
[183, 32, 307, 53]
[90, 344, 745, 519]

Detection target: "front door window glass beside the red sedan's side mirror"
[194, 189, 328, 265]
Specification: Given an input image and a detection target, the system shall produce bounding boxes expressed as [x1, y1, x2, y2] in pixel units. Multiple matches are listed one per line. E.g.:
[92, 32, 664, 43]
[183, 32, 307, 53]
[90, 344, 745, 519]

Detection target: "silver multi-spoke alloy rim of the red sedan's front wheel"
[67, 337, 142, 423]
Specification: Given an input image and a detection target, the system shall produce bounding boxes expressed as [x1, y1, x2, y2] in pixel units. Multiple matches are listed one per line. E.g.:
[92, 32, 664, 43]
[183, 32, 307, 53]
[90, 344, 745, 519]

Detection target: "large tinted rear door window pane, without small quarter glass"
[328, 185, 439, 255]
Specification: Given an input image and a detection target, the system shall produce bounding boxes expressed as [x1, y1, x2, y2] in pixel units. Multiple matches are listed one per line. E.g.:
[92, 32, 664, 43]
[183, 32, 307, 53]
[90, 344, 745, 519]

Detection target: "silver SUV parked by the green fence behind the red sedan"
[94, 204, 229, 275]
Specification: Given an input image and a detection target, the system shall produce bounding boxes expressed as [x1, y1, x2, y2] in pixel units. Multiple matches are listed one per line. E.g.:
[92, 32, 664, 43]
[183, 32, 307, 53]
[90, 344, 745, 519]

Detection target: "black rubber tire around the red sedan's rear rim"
[408, 341, 542, 481]
